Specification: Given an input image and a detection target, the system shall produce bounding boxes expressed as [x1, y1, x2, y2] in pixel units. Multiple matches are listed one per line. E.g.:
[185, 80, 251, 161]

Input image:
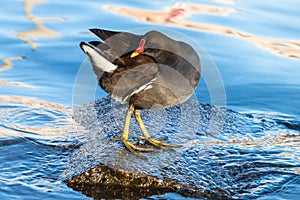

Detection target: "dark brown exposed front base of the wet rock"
[67, 164, 181, 199]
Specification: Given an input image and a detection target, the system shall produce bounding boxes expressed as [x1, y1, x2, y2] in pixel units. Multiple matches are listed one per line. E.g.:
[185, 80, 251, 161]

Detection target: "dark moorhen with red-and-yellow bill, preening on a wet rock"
[80, 28, 201, 154]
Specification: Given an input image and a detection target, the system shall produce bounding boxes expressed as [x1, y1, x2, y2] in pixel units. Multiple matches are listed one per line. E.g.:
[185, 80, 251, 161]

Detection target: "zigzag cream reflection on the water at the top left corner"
[16, 0, 64, 50]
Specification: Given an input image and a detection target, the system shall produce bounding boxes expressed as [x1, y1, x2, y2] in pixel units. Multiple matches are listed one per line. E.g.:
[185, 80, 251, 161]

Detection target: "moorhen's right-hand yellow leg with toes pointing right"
[134, 110, 181, 149]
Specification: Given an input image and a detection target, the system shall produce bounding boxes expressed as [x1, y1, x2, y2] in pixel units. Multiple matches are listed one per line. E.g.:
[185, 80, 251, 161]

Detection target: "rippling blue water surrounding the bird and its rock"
[0, 0, 300, 199]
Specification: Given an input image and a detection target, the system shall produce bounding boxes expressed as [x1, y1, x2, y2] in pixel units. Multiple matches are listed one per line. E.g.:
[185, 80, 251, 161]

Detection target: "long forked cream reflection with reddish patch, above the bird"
[102, 3, 300, 59]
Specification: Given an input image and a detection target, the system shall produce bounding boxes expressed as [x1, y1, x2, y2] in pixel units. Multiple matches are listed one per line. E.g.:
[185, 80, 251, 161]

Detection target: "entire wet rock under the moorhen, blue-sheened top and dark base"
[62, 97, 297, 199]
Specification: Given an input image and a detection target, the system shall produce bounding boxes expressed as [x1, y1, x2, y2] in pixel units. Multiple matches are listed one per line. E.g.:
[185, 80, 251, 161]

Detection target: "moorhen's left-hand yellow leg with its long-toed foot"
[112, 105, 153, 154]
